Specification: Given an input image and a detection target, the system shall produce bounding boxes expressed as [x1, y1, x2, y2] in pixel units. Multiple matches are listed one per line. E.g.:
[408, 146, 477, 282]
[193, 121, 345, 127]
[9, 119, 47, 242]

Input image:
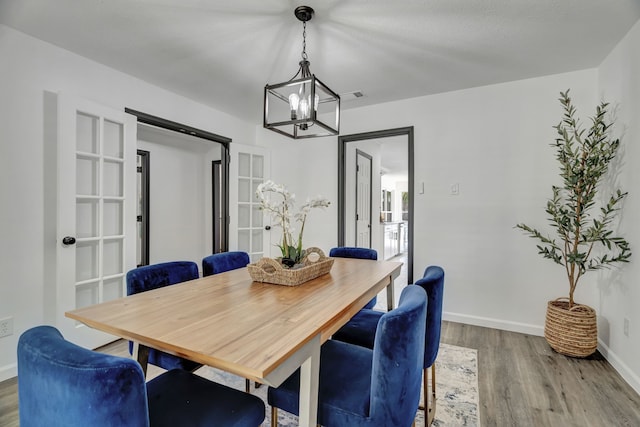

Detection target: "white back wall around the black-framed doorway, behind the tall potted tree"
[256, 70, 597, 335]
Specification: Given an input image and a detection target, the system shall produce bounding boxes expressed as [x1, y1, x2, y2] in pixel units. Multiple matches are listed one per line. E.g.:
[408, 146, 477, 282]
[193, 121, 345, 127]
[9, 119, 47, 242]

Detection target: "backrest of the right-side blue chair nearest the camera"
[370, 286, 427, 426]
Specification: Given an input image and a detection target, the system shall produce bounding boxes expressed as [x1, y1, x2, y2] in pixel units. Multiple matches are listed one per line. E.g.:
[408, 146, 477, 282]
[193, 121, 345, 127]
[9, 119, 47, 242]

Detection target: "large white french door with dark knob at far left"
[56, 95, 136, 348]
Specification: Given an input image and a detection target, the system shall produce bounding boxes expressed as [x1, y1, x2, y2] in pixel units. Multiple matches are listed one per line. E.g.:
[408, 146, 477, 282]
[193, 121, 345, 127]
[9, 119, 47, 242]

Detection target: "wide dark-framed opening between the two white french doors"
[125, 108, 231, 264]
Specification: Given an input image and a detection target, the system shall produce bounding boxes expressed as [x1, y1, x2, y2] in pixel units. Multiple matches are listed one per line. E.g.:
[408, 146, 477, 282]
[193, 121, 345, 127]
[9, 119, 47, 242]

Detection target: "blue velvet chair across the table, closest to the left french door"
[127, 261, 202, 372]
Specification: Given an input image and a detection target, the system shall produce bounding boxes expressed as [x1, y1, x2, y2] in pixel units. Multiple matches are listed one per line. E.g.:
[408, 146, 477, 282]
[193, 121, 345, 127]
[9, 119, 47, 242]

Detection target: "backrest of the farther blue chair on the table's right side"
[415, 265, 444, 369]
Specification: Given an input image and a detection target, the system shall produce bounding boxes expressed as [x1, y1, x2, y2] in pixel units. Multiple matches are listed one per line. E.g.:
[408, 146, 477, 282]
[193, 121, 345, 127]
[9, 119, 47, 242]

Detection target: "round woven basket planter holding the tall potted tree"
[544, 298, 598, 357]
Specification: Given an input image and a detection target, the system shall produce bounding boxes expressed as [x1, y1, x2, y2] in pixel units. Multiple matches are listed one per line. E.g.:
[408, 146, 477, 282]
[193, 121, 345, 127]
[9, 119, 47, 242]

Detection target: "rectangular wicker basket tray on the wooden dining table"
[247, 247, 333, 286]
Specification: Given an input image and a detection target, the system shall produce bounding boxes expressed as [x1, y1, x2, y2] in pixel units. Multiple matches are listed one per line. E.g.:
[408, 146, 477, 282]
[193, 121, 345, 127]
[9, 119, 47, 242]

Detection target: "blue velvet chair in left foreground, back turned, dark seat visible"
[18, 326, 265, 427]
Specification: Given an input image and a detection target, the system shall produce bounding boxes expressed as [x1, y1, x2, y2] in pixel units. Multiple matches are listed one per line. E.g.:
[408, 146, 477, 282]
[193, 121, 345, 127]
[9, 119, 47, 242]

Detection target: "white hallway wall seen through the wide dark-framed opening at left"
[137, 126, 221, 268]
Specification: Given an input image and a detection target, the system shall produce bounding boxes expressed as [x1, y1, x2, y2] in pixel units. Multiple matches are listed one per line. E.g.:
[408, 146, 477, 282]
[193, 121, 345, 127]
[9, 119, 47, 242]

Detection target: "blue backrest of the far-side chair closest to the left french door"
[127, 261, 199, 295]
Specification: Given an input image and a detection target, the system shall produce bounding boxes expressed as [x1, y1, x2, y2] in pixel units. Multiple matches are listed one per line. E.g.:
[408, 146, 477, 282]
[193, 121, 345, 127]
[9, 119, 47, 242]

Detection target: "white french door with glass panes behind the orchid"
[229, 143, 272, 262]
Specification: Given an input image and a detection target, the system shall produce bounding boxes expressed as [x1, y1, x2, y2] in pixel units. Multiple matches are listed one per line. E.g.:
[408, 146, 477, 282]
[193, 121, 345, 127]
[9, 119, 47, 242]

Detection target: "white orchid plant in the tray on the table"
[256, 180, 330, 267]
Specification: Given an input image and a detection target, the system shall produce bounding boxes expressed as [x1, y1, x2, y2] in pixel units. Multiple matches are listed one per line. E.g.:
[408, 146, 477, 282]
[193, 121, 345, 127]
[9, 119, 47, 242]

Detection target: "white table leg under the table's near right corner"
[299, 339, 320, 427]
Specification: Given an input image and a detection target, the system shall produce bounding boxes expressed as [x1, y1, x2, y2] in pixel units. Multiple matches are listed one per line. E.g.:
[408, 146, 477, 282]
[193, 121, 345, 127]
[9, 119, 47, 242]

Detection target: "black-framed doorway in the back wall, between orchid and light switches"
[338, 126, 414, 283]
